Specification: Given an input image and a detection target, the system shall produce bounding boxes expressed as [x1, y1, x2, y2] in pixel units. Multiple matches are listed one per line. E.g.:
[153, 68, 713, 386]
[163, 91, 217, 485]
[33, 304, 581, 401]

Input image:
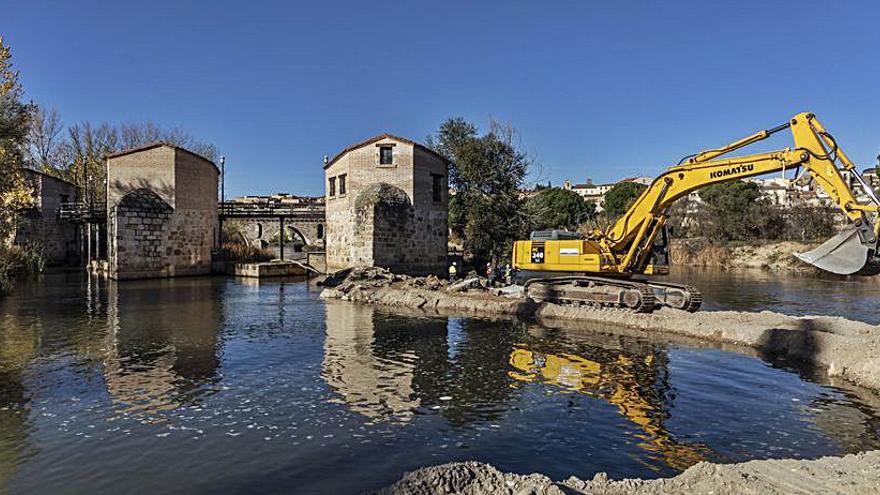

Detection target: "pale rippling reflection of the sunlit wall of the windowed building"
[321, 300, 419, 421]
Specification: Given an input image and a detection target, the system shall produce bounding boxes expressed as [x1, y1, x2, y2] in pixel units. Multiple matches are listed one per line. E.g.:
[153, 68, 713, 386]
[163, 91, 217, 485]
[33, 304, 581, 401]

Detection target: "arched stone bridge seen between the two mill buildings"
[220, 202, 324, 251]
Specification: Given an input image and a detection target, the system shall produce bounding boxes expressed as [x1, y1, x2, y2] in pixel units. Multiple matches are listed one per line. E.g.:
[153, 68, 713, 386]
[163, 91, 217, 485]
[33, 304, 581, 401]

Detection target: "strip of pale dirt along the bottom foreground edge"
[377, 451, 880, 495]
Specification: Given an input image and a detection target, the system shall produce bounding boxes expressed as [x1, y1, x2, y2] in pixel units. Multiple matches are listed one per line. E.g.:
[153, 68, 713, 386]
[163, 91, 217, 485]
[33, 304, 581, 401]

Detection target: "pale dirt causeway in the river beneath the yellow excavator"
[321, 269, 880, 390]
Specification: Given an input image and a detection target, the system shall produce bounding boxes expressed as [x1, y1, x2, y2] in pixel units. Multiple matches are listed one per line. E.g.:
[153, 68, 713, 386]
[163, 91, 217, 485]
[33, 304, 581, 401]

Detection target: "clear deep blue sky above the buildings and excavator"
[0, 0, 880, 195]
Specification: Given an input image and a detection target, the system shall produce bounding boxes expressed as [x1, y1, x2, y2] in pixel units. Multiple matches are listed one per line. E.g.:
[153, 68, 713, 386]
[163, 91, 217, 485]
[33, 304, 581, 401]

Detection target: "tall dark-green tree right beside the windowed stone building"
[427, 117, 531, 265]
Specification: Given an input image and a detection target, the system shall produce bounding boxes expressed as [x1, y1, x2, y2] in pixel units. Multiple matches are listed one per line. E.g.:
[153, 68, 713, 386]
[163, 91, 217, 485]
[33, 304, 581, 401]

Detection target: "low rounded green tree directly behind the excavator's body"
[526, 187, 596, 230]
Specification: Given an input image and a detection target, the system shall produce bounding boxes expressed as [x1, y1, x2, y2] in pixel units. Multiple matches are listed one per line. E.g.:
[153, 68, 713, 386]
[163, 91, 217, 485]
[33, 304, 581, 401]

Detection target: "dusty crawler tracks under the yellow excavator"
[523, 276, 657, 313]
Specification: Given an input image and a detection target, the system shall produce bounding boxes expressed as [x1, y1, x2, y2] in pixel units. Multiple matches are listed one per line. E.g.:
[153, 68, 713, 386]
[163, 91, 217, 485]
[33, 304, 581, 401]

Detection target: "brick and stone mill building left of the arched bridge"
[107, 143, 220, 279]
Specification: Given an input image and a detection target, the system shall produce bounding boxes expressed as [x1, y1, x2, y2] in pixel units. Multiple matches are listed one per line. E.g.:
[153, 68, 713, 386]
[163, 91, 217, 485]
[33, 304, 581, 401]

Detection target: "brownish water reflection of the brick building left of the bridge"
[104, 279, 222, 419]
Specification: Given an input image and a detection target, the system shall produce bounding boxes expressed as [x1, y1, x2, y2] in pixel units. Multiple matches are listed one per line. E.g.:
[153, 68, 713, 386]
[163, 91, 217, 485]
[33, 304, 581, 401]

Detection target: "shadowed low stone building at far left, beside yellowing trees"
[14, 169, 79, 265]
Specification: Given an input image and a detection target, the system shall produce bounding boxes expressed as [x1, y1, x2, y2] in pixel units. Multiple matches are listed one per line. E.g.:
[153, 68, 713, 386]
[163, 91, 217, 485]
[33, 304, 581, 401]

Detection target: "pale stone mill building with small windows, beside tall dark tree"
[324, 134, 449, 274]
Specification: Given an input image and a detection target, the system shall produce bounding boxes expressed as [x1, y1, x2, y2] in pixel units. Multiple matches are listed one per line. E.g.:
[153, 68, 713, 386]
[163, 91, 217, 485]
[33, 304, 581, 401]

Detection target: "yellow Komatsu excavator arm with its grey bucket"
[593, 113, 880, 274]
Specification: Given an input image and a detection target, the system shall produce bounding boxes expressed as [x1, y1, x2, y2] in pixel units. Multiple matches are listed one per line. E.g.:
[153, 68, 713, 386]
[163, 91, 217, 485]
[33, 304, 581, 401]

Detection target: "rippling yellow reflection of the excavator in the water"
[509, 346, 708, 471]
